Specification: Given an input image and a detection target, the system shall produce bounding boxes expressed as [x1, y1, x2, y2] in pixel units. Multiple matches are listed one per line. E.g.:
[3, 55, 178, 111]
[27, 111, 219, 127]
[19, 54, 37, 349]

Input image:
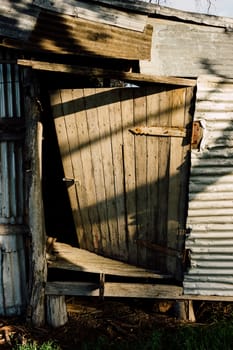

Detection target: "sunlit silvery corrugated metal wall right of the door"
[184, 77, 233, 296]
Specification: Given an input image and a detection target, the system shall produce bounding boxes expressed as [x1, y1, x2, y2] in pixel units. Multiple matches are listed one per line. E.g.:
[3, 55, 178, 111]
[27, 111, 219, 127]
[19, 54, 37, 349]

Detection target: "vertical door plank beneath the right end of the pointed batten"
[167, 89, 185, 275]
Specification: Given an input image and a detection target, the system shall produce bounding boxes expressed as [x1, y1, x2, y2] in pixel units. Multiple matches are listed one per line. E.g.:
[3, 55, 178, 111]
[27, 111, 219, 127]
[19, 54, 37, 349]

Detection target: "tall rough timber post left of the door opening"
[23, 69, 47, 326]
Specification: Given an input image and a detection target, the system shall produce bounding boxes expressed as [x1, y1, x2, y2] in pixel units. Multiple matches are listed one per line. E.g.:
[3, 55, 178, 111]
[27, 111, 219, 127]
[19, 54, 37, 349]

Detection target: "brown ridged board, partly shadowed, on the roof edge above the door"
[26, 10, 153, 60]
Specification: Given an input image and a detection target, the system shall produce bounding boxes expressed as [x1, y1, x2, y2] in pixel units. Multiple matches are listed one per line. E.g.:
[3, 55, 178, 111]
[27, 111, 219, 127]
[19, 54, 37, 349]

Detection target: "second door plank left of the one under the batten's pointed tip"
[109, 89, 127, 260]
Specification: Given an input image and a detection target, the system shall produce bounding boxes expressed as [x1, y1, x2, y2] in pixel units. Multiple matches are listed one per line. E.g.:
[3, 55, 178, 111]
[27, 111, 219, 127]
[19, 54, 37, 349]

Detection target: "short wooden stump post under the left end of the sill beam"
[47, 295, 68, 328]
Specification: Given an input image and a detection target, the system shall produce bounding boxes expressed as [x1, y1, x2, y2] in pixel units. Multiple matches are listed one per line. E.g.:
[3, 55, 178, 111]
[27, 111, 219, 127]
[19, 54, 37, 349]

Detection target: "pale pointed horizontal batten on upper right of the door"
[129, 126, 186, 137]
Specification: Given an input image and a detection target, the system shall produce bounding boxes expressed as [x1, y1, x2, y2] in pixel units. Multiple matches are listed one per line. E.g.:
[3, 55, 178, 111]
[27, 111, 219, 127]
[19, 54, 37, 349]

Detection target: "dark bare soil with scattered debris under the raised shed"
[0, 298, 233, 350]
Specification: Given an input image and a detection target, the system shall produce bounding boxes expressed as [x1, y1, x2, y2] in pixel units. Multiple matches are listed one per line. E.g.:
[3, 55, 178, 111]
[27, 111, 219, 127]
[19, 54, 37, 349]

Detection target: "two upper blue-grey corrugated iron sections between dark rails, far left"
[0, 63, 23, 224]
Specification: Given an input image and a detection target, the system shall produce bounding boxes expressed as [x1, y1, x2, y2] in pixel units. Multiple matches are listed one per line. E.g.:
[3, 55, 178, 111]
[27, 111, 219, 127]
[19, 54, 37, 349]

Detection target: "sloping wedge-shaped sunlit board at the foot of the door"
[48, 242, 172, 279]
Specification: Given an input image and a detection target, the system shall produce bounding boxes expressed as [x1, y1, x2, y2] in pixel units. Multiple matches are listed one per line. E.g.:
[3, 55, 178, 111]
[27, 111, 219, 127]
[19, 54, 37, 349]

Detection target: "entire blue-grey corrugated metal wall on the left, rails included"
[0, 51, 26, 316]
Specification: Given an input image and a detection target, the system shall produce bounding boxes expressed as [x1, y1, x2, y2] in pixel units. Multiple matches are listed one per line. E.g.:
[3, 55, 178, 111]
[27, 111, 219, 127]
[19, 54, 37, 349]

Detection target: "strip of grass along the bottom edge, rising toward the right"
[13, 304, 233, 350]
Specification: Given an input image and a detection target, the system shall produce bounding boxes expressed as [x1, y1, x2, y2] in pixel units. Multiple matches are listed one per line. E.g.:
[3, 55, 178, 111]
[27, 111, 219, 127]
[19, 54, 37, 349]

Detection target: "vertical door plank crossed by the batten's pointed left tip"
[134, 88, 148, 266]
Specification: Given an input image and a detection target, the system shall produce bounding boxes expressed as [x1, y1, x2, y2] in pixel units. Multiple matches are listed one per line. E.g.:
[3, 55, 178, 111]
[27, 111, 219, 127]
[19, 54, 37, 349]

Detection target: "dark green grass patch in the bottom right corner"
[81, 320, 233, 350]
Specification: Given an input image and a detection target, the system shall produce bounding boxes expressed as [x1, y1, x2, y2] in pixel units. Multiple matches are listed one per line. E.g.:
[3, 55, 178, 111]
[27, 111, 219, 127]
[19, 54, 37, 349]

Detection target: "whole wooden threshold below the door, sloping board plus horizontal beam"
[45, 242, 233, 302]
